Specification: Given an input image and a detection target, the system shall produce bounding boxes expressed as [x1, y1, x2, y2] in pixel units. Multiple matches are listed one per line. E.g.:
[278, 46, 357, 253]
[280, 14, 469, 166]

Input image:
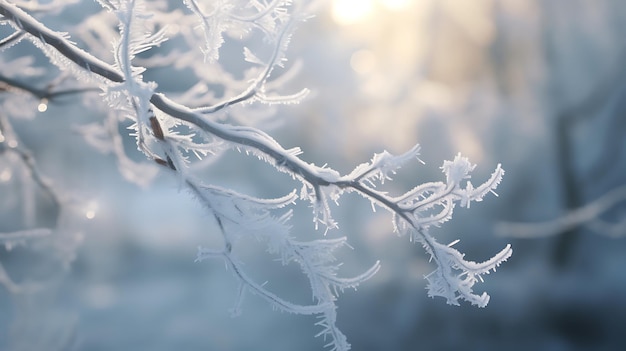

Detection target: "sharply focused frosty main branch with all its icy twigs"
[0, 0, 512, 351]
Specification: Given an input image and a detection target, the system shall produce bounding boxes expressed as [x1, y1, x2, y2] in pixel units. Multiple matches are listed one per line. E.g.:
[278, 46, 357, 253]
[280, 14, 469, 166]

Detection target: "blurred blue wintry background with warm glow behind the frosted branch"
[0, 0, 626, 351]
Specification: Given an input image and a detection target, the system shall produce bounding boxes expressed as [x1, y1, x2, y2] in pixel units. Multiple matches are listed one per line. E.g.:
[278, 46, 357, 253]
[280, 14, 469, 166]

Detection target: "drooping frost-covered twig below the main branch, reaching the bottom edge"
[187, 176, 380, 350]
